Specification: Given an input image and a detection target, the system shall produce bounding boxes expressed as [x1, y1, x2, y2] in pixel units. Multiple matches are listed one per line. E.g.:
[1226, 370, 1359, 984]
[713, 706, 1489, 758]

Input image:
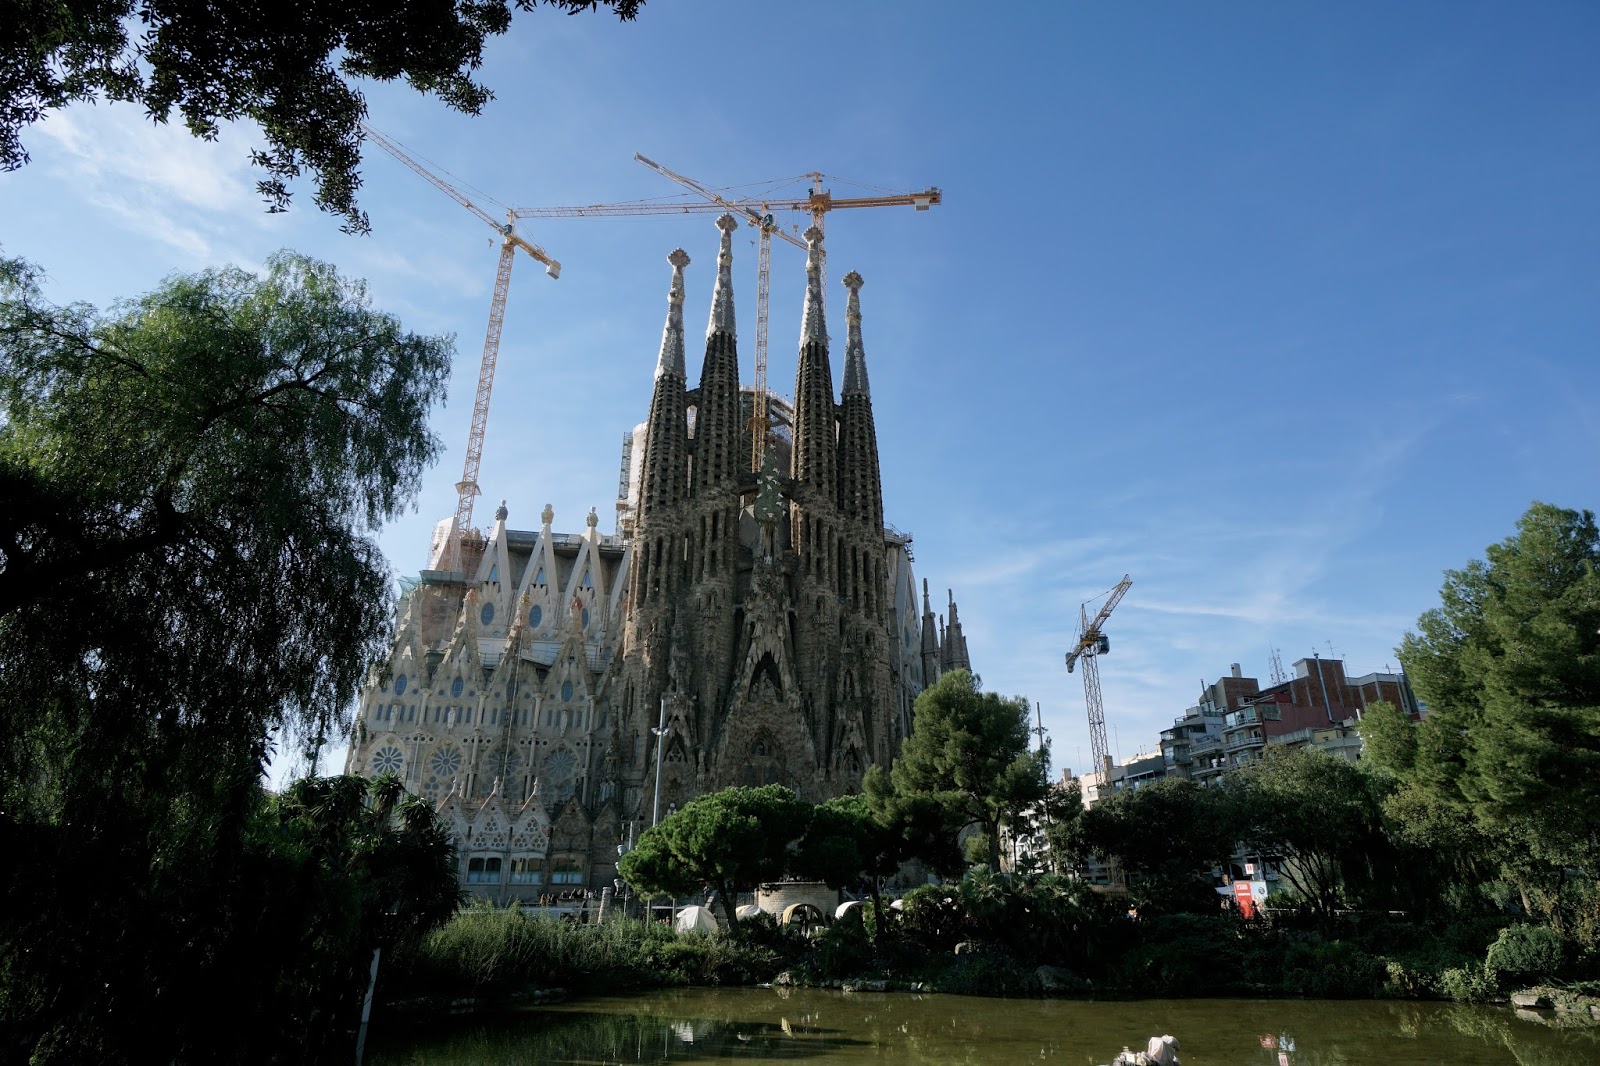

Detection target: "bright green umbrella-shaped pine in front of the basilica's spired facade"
[618, 784, 811, 936]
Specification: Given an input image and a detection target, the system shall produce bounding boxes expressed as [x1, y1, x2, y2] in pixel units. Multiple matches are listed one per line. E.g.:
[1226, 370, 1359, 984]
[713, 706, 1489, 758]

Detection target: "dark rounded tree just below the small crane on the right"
[1083, 778, 1242, 912]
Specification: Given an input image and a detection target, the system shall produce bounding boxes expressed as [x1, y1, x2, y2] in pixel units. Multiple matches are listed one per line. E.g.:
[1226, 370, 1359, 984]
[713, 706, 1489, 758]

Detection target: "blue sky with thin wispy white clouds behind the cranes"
[0, 0, 1600, 768]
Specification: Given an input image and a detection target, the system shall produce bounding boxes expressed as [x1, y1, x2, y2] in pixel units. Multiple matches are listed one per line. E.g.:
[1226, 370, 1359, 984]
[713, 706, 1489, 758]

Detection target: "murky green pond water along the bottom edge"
[368, 989, 1600, 1066]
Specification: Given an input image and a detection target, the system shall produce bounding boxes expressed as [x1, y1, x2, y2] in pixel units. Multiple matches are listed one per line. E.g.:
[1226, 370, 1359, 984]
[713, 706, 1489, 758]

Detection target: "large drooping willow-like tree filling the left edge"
[0, 253, 453, 1061]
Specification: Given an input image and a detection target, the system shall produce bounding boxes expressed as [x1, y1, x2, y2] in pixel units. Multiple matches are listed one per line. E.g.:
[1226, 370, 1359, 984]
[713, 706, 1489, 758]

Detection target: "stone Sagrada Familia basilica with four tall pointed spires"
[347, 214, 971, 901]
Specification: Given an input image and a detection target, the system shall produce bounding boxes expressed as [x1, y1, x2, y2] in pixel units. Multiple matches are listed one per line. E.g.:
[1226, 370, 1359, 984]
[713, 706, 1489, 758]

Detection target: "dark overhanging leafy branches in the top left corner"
[0, 0, 643, 232]
